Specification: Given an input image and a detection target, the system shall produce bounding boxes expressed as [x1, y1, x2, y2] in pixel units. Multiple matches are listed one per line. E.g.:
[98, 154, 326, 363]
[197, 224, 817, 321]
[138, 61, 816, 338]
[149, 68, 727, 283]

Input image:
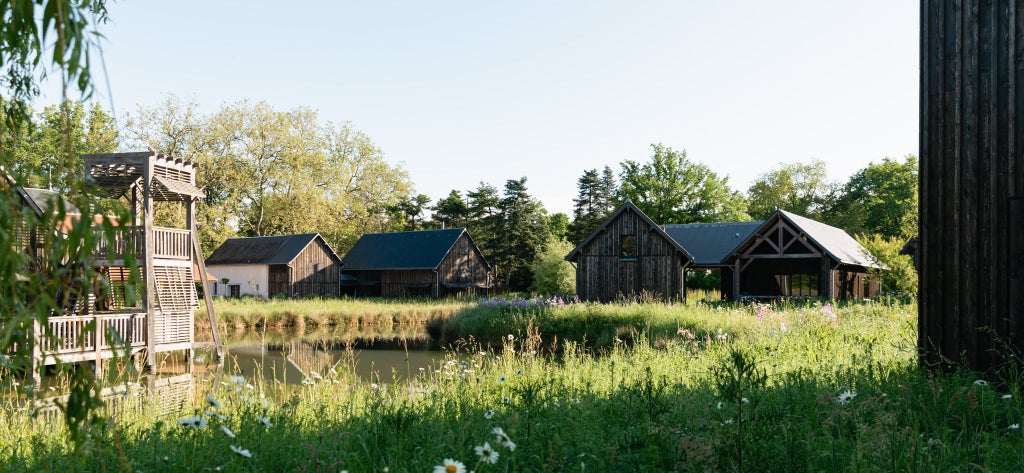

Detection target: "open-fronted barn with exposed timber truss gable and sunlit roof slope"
[723, 210, 882, 299]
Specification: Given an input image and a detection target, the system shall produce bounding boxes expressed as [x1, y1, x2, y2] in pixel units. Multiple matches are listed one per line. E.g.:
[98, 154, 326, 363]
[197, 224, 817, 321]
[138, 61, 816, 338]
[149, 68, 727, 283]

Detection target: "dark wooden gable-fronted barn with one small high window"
[565, 201, 693, 302]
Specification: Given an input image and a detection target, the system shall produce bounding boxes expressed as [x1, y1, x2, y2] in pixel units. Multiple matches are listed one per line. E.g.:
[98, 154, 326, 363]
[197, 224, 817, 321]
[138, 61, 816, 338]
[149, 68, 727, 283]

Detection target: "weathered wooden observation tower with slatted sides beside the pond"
[82, 152, 223, 369]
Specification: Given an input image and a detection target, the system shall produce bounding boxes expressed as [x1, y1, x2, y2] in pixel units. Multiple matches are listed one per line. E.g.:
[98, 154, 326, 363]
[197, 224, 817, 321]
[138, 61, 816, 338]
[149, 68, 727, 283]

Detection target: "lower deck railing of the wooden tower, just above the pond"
[39, 312, 145, 355]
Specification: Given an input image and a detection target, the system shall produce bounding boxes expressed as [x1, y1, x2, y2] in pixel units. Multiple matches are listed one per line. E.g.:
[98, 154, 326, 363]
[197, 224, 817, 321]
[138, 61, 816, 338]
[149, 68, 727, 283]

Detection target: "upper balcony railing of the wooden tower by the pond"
[93, 226, 191, 260]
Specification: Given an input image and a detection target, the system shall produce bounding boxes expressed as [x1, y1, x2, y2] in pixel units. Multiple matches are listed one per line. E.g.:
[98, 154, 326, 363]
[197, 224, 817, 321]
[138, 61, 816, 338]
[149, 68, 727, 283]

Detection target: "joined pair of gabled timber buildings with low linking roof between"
[565, 202, 883, 301]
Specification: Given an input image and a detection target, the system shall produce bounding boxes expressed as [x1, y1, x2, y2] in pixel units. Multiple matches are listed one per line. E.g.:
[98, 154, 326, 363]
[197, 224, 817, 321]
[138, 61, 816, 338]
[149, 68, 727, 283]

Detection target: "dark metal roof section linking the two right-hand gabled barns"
[665, 221, 764, 266]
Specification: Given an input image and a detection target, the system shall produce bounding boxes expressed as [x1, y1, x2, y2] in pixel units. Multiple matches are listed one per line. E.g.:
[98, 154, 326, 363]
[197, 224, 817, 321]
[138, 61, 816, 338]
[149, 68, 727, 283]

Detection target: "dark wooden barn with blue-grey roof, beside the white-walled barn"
[342, 228, 493, 298]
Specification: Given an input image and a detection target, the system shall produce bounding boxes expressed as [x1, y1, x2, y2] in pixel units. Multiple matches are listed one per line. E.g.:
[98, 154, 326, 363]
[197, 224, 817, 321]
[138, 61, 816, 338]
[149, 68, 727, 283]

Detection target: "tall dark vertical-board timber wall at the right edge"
[919, 0, 1024, 370]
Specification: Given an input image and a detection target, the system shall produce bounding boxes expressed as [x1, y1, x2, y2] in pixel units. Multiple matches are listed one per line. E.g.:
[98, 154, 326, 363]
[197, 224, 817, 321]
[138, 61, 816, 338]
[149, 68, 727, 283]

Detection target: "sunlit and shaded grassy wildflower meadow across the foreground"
[0, 301, 1024, 472]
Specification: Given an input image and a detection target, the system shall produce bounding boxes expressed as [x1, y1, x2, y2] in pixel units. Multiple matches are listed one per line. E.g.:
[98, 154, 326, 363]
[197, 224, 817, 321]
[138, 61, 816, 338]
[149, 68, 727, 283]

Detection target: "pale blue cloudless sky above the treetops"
[42, 0, 920, 215]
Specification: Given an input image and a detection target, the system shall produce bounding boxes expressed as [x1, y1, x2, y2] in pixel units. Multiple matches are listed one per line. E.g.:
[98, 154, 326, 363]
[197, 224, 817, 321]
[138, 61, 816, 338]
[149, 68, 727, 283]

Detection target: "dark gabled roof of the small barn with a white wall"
[206, 233, 341, 266]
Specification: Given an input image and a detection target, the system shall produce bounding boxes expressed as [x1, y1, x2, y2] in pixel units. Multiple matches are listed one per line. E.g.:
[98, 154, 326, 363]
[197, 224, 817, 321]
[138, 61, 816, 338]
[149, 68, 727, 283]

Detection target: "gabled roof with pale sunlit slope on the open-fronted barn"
[730, 210, 885, 269]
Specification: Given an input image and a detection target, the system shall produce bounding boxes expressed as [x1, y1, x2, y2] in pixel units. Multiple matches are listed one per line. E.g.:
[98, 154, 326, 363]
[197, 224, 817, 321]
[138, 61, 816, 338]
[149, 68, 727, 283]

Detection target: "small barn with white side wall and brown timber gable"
[206, 233, 341, 297]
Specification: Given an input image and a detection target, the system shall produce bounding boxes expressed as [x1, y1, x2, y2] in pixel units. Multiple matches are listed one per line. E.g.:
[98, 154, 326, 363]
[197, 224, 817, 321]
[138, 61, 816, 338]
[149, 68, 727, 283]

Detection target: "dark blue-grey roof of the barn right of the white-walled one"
[342, 228, 489, 270]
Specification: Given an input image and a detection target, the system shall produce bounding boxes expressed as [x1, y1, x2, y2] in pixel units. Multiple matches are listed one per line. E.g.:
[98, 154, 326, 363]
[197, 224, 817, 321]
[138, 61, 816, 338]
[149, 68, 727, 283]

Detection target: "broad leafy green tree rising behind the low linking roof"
[618, 144, 750, 223]
